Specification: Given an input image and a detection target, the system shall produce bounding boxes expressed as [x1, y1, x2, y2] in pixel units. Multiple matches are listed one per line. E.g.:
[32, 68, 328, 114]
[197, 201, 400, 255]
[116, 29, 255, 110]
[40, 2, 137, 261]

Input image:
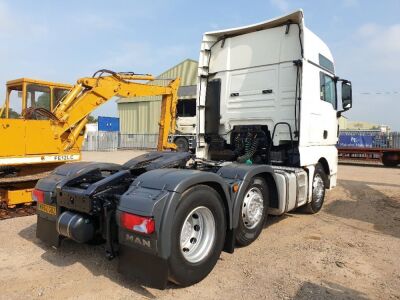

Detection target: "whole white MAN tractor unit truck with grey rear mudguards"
[33, 10, 352, 288]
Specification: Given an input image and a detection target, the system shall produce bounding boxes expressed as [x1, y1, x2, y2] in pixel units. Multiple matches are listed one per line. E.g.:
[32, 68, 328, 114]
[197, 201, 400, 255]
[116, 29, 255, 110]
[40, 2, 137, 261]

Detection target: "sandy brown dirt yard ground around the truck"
[0, 151, 400, 299]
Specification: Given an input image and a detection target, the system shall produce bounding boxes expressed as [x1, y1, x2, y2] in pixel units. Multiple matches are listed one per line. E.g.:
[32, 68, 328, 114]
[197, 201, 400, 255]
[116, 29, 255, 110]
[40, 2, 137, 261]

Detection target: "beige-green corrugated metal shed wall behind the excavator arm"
[117, 59, 198, 134]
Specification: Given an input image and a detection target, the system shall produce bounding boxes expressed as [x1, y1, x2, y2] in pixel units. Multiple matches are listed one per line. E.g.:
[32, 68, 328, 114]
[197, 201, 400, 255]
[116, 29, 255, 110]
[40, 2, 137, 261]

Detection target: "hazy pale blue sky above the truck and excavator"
[0, 0, 400, 130]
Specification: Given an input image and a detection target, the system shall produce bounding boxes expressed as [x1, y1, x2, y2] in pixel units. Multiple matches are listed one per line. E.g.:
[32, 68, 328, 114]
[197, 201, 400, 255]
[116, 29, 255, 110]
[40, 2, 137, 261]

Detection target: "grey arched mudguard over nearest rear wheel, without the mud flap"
[118, 169, 232, 258]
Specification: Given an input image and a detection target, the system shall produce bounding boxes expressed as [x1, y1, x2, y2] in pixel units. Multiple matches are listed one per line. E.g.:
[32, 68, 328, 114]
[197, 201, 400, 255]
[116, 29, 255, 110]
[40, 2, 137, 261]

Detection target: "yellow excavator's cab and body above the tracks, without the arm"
[0, 78, 72, 157]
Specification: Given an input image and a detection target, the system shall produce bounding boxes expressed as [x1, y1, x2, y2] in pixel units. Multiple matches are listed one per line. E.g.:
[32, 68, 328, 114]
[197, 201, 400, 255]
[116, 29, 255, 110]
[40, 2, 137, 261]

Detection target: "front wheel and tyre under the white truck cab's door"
[304, 163, 328, 214]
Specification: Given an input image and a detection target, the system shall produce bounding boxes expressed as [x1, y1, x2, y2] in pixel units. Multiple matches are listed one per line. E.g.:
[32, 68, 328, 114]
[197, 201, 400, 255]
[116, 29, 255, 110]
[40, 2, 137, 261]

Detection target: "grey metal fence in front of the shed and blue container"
[82, 131, 158, 151]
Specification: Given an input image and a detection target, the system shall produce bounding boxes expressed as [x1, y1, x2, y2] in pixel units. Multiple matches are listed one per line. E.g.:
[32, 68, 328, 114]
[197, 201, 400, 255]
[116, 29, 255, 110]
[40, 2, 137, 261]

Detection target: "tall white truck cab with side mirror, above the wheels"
[196, 10, 351, 188]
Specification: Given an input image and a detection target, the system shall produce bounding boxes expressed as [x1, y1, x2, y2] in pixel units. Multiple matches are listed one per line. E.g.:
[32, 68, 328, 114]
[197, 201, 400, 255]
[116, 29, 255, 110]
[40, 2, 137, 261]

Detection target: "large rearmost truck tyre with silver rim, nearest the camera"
[168, 185, 226, 286]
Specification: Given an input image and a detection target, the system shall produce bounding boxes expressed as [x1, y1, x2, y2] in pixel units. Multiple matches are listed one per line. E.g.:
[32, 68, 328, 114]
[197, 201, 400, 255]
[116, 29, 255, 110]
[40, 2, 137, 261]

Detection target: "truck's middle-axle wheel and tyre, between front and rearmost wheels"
[236, 177, 269, 246]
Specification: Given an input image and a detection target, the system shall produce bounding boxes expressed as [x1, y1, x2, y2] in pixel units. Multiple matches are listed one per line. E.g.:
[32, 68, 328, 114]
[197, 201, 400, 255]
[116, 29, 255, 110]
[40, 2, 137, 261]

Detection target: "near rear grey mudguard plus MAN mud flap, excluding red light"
[117, 169, 232, 288]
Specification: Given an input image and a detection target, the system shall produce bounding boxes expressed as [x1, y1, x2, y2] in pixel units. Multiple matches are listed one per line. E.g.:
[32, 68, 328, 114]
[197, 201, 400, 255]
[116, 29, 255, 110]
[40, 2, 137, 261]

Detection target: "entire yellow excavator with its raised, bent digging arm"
[0, 70, 179, 207]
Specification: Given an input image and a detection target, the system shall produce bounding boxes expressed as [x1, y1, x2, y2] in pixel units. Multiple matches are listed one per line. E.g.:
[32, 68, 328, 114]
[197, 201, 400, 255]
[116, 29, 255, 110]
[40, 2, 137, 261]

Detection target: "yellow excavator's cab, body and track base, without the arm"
[0, 78, 72, 207]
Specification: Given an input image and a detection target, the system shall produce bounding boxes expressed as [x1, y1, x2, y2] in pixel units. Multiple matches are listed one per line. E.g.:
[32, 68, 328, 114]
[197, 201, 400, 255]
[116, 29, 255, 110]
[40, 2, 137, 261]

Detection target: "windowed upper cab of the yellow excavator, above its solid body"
[0, 78, 72, 120]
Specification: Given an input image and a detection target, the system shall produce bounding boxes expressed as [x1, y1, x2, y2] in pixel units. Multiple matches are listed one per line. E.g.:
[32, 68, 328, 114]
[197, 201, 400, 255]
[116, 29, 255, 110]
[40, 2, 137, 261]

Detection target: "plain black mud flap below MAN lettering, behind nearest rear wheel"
[118, 244, 169, 290]
